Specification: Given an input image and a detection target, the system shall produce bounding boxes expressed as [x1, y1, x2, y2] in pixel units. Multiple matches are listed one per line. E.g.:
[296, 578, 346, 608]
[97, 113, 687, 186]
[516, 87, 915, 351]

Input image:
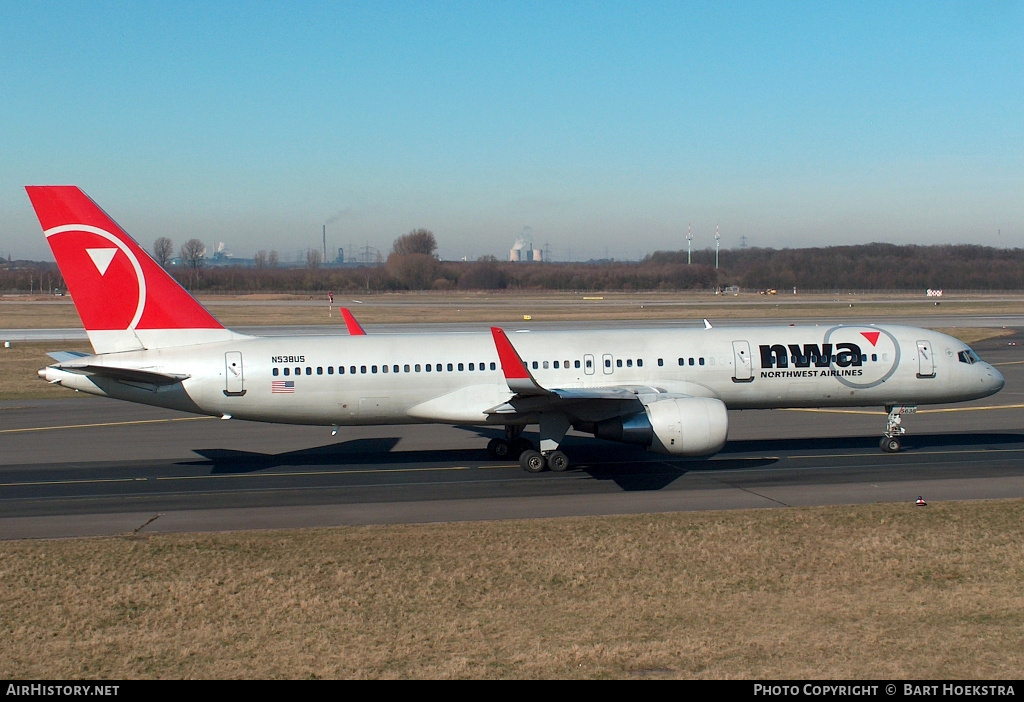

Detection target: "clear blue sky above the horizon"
[0, 0, 1024, 260]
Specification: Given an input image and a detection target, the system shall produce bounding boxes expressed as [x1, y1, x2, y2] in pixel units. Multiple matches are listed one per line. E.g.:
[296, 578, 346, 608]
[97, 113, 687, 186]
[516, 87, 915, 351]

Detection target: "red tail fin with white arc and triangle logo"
[26, 185, 230, 353]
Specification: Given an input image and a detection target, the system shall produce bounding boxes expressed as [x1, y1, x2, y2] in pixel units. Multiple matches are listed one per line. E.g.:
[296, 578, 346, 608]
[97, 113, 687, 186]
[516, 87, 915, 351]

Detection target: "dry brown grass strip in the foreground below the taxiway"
[0, 500, 1024, 679]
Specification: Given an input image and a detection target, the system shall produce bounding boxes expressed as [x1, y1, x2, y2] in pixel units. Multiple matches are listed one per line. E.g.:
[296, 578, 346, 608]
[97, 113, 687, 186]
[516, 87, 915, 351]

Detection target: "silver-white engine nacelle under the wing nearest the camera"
[593, 397, 729, 455]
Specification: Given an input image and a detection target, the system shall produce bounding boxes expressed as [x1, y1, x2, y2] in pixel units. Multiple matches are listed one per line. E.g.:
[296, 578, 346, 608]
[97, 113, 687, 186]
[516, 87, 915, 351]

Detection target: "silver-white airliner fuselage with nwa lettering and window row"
[41, 324, 1004, 426]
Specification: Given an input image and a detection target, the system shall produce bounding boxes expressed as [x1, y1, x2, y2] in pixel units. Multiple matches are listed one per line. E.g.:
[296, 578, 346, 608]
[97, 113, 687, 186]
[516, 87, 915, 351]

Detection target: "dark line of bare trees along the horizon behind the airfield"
[6, 239, 1024, 293]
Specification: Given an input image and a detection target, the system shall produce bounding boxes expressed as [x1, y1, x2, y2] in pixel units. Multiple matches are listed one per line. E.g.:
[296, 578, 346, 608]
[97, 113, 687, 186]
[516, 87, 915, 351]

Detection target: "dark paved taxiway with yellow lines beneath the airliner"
[0, 337, 1024, 538]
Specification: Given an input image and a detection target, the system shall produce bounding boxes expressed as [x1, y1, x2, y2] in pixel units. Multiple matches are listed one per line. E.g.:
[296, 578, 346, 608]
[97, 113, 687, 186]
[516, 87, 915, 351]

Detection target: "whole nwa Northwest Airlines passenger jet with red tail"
[26, 185, 1004, 473]
